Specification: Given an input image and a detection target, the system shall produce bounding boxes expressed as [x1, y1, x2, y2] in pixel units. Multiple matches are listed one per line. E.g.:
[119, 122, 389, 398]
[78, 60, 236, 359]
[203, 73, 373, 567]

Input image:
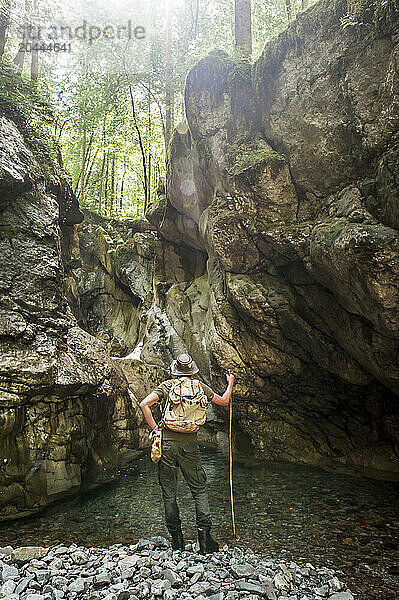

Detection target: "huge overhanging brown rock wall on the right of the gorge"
[142, 0, 399, 472]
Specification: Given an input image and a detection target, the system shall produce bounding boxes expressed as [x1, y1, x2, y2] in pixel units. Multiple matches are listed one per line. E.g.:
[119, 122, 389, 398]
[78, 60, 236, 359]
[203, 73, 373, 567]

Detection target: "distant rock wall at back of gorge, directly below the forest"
[64, 211, 156, 356]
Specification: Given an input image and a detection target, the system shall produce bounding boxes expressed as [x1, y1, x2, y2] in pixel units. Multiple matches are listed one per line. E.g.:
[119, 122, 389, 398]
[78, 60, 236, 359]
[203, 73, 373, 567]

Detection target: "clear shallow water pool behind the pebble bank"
[0, 447, 399, 600]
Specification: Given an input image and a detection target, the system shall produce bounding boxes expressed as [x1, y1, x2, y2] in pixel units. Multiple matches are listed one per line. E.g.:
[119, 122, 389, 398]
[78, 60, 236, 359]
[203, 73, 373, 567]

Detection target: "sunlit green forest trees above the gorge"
[0, 0, 318, 224]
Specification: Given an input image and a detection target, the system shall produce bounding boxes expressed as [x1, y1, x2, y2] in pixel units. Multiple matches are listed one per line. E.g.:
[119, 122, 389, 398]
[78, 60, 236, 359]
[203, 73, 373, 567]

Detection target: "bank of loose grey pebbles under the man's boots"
[0, 536, 354, 600]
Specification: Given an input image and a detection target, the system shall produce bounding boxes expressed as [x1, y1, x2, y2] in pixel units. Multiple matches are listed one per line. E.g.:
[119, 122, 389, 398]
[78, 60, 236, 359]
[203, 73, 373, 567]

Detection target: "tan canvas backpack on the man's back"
[163, 377, 208, 433]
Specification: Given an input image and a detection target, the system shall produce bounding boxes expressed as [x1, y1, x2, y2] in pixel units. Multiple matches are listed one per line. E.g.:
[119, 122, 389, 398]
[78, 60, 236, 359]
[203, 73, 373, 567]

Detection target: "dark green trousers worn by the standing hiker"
[158, 440, 212, 534]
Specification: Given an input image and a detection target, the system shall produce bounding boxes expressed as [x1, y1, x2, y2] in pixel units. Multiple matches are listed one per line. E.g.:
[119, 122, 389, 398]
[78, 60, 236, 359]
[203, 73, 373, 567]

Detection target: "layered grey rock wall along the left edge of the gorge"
[0, 96, 138, 519]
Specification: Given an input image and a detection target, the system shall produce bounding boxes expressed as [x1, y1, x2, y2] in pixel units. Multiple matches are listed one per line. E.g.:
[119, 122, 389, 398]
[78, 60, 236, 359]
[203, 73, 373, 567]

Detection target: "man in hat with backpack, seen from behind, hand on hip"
[140, 354, 234, 554]
